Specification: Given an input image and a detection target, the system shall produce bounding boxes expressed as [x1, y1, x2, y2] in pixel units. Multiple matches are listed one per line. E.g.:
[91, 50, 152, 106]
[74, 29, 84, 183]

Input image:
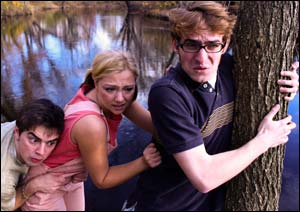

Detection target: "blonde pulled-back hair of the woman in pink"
[84, 50, 138, 87]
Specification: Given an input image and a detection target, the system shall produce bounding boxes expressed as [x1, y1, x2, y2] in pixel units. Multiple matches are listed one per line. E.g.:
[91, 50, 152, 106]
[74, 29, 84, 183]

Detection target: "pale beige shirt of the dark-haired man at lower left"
[1, 121, 28, 211]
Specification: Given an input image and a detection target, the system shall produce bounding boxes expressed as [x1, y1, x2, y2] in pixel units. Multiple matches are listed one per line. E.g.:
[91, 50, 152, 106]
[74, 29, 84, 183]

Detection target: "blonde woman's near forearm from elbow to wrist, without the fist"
[91, 157, 149, 189]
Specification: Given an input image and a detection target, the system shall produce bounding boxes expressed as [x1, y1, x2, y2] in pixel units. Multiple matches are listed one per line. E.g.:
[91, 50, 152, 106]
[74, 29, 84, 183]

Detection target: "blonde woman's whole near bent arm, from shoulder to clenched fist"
[71, 115, 160, 188]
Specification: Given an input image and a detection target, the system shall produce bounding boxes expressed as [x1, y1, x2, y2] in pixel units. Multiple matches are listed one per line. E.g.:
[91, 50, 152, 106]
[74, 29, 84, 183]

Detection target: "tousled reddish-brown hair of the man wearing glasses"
[169, 1, 236, 41]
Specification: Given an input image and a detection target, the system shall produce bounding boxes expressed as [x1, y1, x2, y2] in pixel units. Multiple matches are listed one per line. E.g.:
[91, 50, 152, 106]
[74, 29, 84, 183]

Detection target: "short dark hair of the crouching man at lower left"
[16, 98, 64, 134]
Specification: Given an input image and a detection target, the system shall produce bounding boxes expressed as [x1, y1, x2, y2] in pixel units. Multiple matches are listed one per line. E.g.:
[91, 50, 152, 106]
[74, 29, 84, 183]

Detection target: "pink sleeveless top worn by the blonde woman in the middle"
[44, 86, 122, 168]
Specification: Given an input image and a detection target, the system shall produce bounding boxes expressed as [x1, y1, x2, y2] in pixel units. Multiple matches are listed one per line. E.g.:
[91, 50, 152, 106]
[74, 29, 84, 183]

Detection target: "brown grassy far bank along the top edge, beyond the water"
[1, 1, 171, 20]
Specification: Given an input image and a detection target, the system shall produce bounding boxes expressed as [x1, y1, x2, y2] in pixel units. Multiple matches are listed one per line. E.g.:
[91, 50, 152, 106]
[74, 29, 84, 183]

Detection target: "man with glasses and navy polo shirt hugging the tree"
[123, 1, 298, 211]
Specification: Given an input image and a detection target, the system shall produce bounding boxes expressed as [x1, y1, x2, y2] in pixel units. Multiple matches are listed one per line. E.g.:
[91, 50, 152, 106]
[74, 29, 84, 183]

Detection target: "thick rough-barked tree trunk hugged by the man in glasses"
[225, 1, 299, 211]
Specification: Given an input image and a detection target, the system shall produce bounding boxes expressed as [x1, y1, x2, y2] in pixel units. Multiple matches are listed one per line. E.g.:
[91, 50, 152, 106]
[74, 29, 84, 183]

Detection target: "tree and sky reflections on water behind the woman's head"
[1, 9, 171, 120]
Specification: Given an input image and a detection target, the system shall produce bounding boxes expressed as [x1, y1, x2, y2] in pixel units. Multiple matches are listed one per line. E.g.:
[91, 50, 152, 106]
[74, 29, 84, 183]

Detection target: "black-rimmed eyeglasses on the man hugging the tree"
[177, 39, 225, 53]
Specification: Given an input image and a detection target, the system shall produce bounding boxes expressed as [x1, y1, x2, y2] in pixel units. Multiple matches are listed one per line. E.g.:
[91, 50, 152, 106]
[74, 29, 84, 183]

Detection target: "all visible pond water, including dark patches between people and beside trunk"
[1, 7, 299, 210]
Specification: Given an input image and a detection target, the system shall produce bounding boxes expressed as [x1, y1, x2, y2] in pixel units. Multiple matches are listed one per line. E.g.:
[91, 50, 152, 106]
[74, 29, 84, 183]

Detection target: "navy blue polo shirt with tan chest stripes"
[129, 54, 234, 211]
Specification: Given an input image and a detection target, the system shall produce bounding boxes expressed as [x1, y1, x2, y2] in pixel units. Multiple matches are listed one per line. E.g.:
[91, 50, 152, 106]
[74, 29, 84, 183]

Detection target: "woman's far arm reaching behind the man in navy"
[124, 101, 154, 134]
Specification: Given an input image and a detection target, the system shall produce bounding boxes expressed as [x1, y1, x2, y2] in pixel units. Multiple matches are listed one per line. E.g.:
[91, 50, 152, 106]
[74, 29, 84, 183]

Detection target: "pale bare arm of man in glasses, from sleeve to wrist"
[174, 137, 267, 193]
